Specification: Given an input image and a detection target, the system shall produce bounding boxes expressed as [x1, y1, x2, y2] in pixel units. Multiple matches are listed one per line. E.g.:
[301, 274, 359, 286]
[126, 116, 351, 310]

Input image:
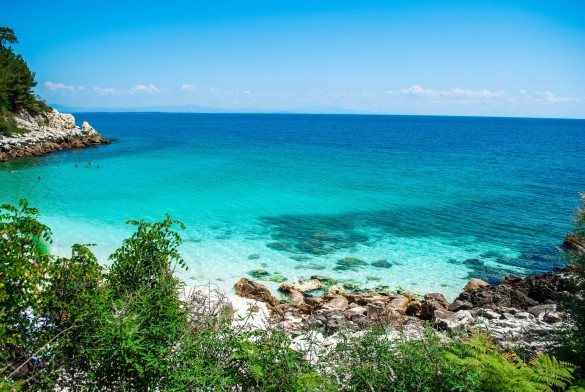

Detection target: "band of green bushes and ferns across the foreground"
[0, 201, 583, 391]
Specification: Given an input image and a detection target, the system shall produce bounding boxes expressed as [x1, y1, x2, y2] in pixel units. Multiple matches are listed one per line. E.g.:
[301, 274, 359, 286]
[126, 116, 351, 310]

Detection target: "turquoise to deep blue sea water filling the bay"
[0, 113, 585, 298]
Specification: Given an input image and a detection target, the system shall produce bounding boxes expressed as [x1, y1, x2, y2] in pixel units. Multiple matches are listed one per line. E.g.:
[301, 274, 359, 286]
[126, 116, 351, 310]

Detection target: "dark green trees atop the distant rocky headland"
[0, 27, 48, 135]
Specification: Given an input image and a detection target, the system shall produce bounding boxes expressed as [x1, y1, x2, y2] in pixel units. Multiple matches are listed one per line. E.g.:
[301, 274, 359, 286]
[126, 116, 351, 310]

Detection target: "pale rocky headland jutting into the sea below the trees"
[0, 109, 110, 162]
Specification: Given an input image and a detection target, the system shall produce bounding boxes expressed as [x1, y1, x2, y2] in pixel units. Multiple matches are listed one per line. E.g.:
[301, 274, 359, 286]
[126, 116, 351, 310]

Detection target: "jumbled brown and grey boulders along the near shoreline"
[234, 268, 573, 352]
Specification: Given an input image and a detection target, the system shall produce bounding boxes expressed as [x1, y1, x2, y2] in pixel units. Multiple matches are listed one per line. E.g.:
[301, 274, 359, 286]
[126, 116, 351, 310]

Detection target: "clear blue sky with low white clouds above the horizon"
[0, 0, 585, 118]
